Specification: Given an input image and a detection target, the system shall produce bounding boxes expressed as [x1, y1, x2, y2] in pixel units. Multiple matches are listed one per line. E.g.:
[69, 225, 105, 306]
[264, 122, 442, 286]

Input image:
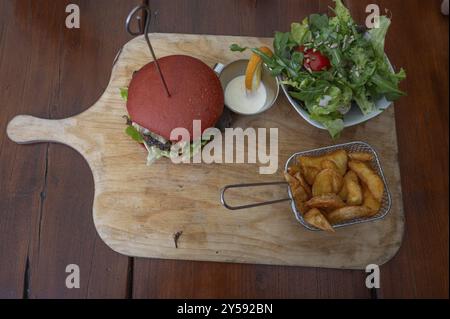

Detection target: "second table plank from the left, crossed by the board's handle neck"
[29, 0, 139, 298]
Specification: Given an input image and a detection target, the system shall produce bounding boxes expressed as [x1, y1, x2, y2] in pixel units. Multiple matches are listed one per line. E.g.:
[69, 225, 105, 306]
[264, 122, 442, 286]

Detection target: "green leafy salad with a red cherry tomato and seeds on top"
[231, 0, 406, 138]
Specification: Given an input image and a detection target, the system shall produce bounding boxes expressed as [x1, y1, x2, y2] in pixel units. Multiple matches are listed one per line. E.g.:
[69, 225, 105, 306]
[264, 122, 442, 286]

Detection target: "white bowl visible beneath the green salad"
[279, 60, 394, 130]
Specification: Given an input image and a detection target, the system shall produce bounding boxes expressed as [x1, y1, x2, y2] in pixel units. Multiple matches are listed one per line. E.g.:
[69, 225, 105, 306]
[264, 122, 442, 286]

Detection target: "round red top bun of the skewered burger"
[127, 55, 224, 140]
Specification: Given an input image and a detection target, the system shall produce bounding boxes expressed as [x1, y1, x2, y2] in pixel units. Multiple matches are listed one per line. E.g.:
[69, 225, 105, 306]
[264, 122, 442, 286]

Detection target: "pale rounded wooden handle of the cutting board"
[6, 115, 76, 144]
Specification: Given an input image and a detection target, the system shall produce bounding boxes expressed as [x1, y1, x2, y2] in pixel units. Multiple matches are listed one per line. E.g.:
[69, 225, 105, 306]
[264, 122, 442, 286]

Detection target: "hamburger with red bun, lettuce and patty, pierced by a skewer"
[121, 55, 224, 164]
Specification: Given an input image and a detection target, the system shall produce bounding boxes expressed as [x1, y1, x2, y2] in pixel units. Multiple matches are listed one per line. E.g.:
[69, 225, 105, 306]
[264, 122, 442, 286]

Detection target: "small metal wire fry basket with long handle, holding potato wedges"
[220, 142, 392, 231]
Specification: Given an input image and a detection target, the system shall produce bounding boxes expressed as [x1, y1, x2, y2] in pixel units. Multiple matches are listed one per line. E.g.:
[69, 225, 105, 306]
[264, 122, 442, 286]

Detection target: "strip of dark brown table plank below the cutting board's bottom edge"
[133, 258, 370, 299]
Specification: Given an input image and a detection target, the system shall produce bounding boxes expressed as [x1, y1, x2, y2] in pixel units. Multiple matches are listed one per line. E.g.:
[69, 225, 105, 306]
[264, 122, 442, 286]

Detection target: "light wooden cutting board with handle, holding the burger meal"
[7, 34, 404, 269]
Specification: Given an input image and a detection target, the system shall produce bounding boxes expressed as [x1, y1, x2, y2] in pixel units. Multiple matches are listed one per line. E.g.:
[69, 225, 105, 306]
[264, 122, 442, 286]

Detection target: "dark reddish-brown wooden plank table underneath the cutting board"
[0, 0, 449, 298]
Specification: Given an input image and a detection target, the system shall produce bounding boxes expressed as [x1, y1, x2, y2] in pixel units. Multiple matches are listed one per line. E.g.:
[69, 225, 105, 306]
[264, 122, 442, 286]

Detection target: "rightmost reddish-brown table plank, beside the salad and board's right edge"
[350, 0, 449, 298]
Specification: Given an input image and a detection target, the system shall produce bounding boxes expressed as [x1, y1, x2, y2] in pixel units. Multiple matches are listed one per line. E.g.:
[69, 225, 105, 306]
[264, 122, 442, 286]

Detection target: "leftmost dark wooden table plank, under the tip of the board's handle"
[0, 1, 48, 298]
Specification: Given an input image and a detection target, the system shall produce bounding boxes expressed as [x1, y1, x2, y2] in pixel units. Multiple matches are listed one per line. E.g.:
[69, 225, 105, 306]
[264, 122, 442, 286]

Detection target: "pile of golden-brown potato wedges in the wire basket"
[285, 150, 385, 232]
